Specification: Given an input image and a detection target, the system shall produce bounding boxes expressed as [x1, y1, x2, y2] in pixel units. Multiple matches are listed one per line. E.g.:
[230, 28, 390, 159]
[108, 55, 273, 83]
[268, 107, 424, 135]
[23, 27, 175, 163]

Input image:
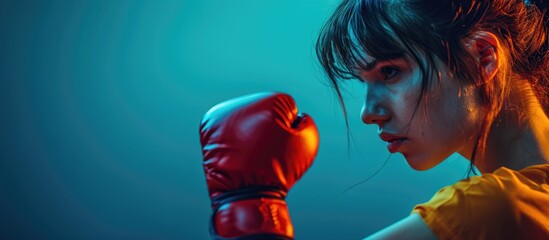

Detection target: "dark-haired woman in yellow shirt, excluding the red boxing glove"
[317, 0, 549, 239]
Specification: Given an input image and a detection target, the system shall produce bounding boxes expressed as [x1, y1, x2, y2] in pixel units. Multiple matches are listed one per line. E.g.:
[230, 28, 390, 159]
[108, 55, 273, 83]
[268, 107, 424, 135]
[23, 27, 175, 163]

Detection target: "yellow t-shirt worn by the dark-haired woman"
[412, 164, 549, 240]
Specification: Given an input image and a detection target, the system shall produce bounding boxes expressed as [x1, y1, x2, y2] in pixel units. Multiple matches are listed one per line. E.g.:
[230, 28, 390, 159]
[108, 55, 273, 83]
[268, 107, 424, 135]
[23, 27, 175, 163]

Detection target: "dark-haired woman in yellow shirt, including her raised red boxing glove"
[200, 0, 549, 239]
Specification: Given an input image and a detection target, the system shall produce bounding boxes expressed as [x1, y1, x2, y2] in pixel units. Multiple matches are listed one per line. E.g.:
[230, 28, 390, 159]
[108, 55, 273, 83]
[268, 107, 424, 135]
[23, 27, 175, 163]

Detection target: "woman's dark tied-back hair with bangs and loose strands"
[316, 0, 549, 172]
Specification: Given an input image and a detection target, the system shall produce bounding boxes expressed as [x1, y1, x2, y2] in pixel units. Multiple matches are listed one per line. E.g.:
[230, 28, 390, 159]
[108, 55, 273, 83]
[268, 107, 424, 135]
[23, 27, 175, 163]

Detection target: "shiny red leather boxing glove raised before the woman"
[200, 93, 318, 239]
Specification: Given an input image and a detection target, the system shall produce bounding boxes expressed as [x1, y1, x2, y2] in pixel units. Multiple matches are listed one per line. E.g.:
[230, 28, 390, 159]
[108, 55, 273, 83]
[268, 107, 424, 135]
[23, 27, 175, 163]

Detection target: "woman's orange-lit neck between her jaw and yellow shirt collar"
[475, 80, 549, 173]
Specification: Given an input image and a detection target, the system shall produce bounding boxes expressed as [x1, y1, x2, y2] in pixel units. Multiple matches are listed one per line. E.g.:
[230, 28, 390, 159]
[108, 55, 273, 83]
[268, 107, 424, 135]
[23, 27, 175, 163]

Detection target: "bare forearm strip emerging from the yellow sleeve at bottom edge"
[365, 213, 437, 239]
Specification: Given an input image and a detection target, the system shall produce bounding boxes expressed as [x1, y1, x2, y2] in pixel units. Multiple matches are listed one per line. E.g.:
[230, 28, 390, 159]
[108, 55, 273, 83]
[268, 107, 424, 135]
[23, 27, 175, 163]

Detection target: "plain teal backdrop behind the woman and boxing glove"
[0, 0, 467, 239]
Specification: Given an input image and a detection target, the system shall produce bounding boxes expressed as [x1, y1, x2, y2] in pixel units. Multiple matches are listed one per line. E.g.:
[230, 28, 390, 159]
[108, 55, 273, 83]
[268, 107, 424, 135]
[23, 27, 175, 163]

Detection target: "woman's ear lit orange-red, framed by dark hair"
[465, 31, 500, 83]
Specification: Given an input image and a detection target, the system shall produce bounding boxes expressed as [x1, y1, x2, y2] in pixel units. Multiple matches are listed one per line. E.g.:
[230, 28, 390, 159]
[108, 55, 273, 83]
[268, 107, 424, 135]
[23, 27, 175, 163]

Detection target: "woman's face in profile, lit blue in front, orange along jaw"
[359, 56, 482, 170]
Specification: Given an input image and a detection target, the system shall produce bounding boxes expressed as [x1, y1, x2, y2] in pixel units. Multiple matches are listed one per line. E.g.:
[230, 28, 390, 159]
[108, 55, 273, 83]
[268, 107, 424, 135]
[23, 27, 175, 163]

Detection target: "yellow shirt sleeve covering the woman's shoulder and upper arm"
[412, 169, 523, 239]
